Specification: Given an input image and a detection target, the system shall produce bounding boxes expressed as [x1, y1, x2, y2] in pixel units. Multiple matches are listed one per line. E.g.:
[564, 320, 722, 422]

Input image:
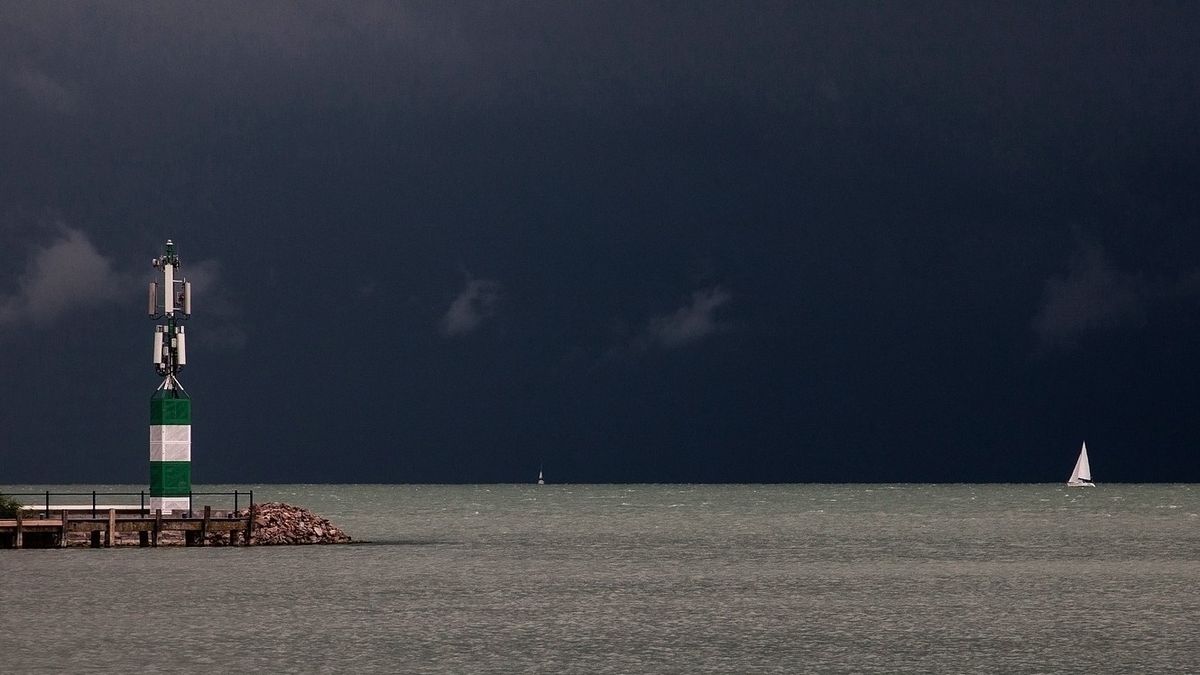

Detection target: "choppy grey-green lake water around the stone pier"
[0, 485, 1200, 673]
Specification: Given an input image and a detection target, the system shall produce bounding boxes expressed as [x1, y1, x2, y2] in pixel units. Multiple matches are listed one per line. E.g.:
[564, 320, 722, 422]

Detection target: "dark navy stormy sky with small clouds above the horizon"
[0, 2, 1200, 483]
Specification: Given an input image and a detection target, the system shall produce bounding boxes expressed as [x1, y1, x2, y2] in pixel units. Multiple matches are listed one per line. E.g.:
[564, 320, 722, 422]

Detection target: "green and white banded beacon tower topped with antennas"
[149, 239, 192, 513]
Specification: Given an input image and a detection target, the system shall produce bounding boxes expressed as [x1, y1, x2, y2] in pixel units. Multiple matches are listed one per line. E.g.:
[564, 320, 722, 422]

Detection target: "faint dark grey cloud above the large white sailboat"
[1033, 244, 1148, 348]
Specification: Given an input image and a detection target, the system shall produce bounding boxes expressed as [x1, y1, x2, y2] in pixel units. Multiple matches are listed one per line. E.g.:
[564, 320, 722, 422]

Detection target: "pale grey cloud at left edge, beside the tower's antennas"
[0, 228, 127, 328]
